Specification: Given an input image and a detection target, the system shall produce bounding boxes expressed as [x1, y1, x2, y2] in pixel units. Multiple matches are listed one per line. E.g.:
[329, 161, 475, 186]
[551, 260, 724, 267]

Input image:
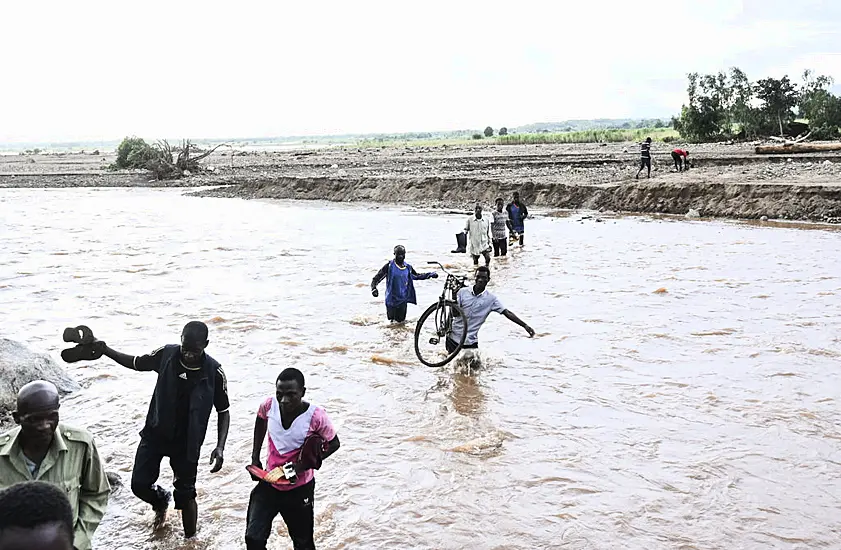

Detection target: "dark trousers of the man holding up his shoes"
[131, 439, 199, 510]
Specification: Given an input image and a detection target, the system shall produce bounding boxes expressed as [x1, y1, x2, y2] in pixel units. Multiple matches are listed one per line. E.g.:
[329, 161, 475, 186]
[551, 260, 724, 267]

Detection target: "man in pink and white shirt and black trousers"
[245, 368, 339, 550]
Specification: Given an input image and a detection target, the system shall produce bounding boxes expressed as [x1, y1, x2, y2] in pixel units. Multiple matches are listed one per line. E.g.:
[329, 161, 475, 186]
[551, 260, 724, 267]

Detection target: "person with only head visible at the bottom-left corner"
[0, 481, 77, 550]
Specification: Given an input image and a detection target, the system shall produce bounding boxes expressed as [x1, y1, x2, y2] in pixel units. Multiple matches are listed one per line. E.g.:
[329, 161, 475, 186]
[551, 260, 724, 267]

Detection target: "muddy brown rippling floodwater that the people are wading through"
[0, 189, 841, 550]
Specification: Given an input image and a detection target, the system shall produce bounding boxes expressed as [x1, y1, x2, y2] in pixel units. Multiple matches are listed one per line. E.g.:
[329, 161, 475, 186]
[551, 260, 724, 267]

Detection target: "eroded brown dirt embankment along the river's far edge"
[195, 177, 841, 221]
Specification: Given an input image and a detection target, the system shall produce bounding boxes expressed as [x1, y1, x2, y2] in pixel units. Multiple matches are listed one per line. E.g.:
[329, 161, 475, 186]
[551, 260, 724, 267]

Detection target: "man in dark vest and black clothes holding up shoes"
[101, 321, 231, 538]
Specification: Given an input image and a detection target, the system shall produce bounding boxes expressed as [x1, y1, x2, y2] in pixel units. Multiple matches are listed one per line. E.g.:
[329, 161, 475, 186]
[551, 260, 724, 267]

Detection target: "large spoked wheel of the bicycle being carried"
[415, 300, 467, 367]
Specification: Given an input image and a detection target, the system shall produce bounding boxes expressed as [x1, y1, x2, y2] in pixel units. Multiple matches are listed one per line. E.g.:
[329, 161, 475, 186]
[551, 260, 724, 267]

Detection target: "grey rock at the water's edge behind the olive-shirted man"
[0, 338, 79, 420]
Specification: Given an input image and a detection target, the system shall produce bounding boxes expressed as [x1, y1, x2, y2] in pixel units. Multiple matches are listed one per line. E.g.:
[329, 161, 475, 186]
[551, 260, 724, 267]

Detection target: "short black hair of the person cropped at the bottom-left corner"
[0, 481, 73, 540]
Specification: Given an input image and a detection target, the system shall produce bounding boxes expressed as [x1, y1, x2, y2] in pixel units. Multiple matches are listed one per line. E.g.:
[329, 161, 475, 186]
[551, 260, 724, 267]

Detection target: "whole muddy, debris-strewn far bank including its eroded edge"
[0, 143, 841, 221]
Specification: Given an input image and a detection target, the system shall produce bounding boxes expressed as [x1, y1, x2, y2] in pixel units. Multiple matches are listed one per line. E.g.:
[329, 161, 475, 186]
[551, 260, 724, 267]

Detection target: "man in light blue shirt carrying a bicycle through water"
[446, 266, 534, 353]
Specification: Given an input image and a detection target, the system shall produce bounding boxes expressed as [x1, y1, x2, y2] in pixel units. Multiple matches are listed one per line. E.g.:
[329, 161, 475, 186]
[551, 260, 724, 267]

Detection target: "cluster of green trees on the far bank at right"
[672, 67, 841, 142]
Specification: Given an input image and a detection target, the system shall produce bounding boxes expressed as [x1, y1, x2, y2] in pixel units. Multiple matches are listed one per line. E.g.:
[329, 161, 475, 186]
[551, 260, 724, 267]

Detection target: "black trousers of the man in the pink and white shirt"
[245, 479, 315, 550]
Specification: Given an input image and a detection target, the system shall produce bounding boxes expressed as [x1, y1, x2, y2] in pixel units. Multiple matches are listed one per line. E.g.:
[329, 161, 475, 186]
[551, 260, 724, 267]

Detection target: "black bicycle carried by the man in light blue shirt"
[415, 262, 467, 367]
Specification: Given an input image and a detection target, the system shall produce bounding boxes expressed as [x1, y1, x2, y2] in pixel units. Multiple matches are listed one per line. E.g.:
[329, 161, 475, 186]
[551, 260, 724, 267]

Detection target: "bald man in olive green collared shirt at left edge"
[0, 380, 111, 550]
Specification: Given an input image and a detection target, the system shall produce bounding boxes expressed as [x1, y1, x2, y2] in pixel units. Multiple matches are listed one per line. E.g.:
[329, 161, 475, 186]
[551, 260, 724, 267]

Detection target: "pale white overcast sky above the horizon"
[0, 0, 841, 142]
